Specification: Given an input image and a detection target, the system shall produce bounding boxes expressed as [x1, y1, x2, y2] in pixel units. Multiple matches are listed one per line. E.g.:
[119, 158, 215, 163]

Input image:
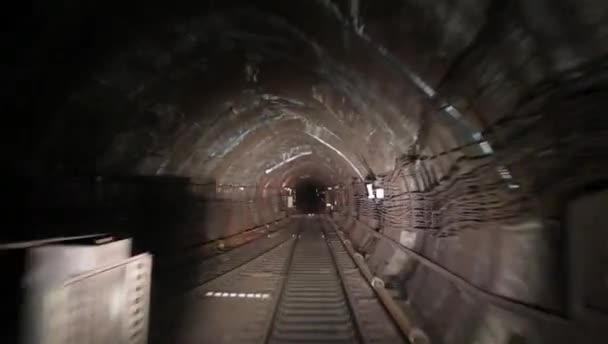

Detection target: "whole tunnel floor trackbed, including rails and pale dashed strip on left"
[157, 218, 407, 344]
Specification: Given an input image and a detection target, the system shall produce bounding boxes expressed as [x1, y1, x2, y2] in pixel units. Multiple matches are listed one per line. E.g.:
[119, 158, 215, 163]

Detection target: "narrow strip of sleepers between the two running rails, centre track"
[268, 223, 360, 344]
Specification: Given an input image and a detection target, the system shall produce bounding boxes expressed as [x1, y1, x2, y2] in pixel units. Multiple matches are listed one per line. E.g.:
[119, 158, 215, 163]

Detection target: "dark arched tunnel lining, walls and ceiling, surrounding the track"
[0, 0, 608, 344]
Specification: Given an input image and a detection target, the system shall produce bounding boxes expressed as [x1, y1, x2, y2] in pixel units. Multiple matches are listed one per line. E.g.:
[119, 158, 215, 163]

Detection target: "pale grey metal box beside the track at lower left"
[21, 237, 152, 344]
